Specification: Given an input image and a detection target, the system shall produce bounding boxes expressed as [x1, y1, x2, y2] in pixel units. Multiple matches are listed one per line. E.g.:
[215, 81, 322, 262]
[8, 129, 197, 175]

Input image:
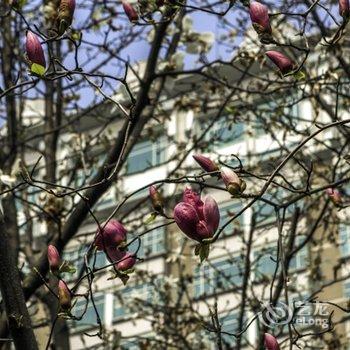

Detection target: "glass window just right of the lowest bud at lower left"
[72, 293, 105, 330]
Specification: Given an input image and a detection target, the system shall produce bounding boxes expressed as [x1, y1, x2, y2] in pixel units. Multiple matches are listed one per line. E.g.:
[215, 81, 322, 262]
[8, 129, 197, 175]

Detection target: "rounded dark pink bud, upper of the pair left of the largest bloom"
[95, 219, 126, 250]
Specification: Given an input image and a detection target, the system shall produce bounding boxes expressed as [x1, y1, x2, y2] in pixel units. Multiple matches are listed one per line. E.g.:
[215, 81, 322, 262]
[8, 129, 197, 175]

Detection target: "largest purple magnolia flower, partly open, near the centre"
[174, 188, 220, 242]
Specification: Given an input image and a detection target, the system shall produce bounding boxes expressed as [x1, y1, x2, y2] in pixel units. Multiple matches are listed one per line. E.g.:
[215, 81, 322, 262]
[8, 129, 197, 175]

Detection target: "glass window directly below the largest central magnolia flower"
[193, 257, 242, 298]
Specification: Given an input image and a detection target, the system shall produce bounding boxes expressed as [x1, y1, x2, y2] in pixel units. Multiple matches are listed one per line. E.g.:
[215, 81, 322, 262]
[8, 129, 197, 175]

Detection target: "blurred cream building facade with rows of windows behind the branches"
[19, 56, 350, 350]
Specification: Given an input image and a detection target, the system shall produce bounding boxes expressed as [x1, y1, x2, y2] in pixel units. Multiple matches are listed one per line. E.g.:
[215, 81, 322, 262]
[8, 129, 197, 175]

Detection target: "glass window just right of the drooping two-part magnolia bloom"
[129, 227, 166, 258]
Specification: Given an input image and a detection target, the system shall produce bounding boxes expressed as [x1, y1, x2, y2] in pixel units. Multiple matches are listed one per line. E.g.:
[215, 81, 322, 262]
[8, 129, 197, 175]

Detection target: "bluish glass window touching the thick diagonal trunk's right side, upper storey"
[126, 137, 166, 174]
